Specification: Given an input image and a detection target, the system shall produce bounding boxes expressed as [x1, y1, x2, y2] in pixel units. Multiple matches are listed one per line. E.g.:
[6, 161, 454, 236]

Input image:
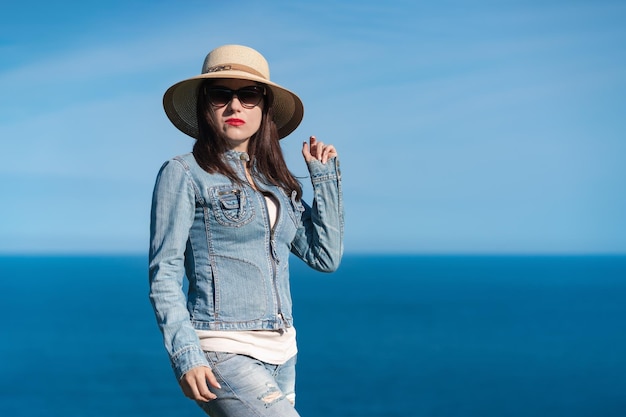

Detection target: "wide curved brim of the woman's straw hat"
[163, 70, 304, 139]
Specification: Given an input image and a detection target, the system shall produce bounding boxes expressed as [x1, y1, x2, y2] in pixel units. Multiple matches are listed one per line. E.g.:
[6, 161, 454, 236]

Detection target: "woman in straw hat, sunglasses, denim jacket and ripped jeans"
[150, 45, 343, 417]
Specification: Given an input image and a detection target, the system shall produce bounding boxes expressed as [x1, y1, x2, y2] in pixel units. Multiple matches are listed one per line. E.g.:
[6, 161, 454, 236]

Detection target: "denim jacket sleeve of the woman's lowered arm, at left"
[149, 161, 209, 379]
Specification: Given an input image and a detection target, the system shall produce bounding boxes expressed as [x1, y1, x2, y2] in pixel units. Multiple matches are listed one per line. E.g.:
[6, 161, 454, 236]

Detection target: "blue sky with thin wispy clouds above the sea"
[0, 0, 626, 253]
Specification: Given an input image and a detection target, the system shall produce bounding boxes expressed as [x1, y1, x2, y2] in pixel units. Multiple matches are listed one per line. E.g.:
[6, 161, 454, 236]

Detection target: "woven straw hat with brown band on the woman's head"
[163, 45, 304, 139]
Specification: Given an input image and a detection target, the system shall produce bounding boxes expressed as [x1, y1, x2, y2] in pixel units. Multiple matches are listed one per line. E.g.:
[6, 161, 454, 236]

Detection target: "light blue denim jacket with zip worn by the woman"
[149, 151, 344, 378]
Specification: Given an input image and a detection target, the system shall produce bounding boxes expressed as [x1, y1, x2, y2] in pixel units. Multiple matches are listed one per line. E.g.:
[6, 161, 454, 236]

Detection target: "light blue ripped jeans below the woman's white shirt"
[198, 352, 299, 417]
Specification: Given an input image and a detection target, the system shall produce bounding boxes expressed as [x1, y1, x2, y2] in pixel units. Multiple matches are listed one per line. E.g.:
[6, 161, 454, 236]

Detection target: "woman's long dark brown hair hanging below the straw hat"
[193, 82, 302, 200]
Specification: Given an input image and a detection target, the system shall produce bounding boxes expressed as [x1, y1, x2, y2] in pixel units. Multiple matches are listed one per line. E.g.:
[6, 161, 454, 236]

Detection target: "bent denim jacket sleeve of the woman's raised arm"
[291, 158, 344, 272]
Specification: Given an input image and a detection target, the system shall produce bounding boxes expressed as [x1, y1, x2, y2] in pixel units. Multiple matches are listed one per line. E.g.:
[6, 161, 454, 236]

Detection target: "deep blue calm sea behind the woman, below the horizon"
[0, 255, 626, 417]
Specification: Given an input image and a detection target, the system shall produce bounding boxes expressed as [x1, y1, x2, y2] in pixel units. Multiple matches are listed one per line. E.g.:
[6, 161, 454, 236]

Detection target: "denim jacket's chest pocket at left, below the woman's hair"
[208, 185, 254, 227]
